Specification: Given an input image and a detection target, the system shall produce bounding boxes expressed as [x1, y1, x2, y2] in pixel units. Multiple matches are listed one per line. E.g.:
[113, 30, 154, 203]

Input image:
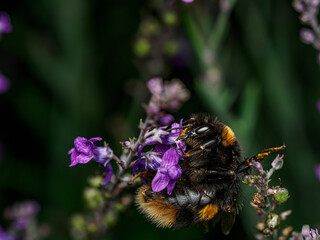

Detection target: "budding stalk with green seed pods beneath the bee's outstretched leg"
[243, 152, 320, 240]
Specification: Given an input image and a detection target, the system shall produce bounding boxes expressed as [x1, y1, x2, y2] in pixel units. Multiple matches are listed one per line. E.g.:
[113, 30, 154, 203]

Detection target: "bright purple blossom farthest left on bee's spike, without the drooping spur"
[68, 137, 102, 167]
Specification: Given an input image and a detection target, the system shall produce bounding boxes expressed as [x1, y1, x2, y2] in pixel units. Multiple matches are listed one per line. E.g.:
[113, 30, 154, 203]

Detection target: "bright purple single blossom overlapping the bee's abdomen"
[151, 148, 182, 195]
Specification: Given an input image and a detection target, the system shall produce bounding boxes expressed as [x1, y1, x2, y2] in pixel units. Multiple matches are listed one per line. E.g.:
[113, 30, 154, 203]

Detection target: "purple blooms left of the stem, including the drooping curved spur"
[68, 137, 113, 185]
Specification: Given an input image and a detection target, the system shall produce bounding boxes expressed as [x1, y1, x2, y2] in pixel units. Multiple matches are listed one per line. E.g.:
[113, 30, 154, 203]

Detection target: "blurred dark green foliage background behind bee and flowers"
[0, 0, 320, 239]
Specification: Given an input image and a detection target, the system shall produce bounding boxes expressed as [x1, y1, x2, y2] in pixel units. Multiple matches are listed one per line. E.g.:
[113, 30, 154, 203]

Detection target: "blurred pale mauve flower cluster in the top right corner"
[293, 0, 320, 64]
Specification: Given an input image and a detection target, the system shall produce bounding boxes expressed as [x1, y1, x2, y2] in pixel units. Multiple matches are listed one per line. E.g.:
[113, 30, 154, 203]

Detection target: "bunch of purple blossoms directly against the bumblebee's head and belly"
[133, 119, 186, 195]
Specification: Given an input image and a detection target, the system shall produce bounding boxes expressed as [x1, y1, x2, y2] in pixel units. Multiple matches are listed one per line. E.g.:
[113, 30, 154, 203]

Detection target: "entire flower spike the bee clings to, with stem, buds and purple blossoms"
[68, 78, 189, 238]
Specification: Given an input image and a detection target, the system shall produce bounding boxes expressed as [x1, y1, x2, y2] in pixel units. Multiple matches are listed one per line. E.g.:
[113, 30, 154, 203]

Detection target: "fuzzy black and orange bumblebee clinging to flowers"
[136, 114, 279, 234]
